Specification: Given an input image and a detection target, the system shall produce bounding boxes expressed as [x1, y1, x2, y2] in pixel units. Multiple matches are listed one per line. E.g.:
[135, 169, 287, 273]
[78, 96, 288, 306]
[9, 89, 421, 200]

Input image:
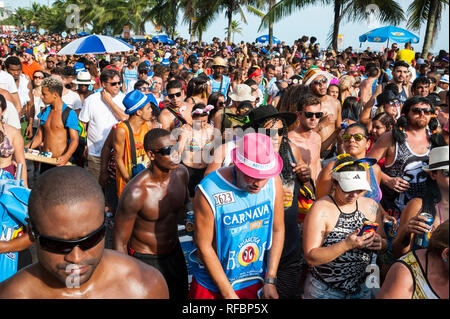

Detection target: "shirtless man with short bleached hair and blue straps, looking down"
[25, 77, 78, 172]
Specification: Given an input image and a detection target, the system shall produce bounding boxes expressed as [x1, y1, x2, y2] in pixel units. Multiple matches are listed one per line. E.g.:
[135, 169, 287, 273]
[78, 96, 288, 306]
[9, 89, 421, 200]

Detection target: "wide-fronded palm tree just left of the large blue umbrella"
[262, 0, 405, 51]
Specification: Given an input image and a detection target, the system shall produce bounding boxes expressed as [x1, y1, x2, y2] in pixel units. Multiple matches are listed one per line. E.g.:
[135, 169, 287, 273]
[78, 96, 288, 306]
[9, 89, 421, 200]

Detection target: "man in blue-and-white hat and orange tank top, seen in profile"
[113, 90, 155, 197]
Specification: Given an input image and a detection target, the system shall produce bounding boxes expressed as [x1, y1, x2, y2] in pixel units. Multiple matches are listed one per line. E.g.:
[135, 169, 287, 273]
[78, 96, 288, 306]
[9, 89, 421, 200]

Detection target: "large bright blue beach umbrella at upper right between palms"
[359, 26, 420, 43]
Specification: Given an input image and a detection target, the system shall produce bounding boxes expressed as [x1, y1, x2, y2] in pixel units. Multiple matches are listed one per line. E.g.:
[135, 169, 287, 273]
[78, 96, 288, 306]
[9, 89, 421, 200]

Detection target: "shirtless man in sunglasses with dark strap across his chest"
[158, 80, 192, 131]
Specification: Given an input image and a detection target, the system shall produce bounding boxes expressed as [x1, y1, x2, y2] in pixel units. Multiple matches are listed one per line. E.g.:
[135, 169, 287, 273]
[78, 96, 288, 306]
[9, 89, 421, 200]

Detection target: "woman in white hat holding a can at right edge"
[392, 145, 449, 258]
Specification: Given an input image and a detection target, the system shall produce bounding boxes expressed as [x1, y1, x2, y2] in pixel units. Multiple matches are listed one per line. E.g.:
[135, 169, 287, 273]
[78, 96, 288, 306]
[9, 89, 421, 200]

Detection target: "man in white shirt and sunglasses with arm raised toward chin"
[79, 69, 128, 178]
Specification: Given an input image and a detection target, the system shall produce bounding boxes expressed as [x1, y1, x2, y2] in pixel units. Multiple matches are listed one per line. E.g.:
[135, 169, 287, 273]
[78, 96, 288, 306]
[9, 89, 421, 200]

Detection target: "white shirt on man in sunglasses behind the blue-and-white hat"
[78, 92, 125, 157]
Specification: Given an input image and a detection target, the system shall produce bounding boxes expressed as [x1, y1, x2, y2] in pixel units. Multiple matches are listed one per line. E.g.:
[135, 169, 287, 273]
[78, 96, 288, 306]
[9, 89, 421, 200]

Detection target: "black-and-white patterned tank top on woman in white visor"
[311, 196, 372, 295]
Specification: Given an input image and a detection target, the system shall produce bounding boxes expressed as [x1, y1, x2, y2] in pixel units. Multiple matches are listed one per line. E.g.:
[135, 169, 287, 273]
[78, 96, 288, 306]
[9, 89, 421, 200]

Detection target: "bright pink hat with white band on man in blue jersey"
[231, 133, 283, 179]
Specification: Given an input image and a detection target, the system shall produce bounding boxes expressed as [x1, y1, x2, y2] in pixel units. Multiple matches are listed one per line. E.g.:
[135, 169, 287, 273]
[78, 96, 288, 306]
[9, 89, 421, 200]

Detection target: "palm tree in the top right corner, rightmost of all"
[407, 0, 448, 58]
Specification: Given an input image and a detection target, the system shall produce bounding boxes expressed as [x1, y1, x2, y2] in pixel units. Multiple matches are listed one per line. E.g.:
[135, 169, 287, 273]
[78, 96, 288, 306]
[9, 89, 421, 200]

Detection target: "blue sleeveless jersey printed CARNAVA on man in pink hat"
[190, 171, 275, 292]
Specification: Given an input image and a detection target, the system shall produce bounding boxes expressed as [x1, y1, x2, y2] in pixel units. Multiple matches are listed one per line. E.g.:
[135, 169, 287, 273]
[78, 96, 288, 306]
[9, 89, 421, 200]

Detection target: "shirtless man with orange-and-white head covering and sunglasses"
[303, 68, 342, 159]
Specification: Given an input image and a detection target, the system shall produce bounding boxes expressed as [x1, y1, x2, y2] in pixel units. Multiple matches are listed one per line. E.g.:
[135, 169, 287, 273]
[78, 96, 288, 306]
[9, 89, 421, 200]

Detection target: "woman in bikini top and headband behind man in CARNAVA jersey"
[178, 103, 214, 198]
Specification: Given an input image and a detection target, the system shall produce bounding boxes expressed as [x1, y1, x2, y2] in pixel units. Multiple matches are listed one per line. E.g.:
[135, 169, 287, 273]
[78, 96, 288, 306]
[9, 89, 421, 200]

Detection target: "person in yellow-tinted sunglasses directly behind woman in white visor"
[316, 123, 382, 203]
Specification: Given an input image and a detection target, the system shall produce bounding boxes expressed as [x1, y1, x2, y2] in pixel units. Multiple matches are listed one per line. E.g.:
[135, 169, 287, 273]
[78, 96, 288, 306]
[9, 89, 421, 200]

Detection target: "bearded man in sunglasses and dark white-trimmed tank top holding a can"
[367, 96, 437, 219]
